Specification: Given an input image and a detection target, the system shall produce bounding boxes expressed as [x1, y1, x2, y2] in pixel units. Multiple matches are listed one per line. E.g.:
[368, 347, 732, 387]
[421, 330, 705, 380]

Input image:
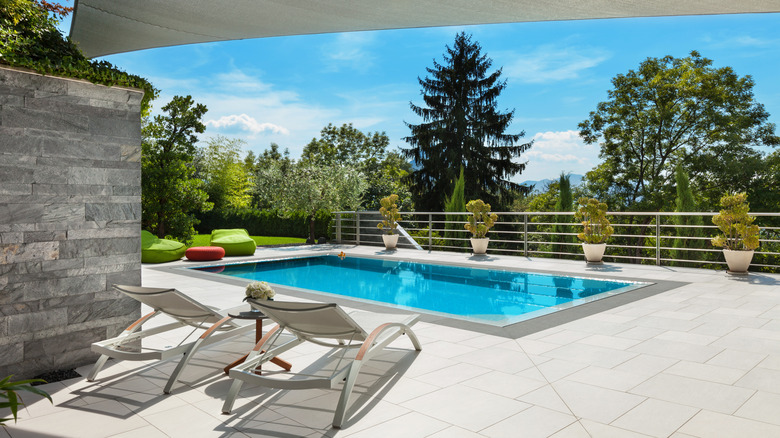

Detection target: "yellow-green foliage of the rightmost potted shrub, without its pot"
[712, 193, 761, 251]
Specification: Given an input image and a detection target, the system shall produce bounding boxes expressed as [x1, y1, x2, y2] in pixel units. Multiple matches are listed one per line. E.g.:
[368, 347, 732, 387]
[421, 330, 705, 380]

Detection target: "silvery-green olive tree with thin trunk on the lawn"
[256, 162, 367, 243]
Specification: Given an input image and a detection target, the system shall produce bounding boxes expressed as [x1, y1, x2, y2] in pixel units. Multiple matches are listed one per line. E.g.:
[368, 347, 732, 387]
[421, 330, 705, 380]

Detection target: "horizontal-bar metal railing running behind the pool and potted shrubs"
[334, 211, 780, 272]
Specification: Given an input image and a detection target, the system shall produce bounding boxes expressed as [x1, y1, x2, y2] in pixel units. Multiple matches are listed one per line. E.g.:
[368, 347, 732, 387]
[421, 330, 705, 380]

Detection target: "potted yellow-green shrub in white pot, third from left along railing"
[574, 198, 615, 263]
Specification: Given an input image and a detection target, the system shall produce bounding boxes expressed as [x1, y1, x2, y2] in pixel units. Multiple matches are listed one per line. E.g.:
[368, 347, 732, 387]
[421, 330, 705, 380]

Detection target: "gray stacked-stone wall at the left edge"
[0, 66, 143, 378]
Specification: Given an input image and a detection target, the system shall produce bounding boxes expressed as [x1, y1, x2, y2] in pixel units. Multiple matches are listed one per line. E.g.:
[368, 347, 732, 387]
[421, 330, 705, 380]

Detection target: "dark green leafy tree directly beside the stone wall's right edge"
[141, 96, 213, 241]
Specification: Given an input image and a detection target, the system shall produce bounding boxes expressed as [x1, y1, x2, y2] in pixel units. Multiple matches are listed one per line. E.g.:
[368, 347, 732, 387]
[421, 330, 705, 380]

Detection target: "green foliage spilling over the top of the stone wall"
[0, 0, 158, 115]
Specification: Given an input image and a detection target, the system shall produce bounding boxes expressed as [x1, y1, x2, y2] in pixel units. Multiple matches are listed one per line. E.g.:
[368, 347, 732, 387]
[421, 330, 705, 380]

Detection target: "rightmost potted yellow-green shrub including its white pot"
[712, 193, 760, 274]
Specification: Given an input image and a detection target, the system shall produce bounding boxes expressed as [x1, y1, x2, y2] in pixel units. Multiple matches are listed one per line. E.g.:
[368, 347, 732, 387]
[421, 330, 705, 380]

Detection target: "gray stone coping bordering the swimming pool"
[150, 247, 689, 339]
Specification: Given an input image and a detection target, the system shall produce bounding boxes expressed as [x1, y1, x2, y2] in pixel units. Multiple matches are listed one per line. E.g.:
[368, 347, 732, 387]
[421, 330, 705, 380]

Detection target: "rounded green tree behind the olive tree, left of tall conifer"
[301, 123, 412, 211]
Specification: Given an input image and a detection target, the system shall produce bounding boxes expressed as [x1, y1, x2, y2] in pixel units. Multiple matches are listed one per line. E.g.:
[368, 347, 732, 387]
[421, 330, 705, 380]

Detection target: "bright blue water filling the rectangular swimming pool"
[193, 255, 645, 326]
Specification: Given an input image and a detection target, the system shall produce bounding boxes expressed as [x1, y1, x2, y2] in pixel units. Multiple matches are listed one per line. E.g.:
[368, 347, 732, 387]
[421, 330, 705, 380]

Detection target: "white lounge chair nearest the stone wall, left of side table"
[87, 285, 255, 394]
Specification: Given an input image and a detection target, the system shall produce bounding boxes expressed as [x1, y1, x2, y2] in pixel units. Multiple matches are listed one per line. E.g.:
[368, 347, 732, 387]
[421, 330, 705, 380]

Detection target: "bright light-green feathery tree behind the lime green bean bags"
[197, 136, 252, 209]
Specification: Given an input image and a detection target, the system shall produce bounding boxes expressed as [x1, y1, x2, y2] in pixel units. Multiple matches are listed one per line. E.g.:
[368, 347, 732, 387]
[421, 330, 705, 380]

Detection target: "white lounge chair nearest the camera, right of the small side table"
[222, 299, 422, 428]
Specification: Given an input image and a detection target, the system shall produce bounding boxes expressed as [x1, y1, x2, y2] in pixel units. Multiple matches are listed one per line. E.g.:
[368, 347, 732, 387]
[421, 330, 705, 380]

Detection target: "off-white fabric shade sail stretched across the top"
[71, 0, 780, 57]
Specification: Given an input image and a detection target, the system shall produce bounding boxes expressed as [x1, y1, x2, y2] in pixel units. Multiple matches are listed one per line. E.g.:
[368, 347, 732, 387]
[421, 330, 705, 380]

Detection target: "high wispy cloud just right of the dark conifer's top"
[502, 44, 610, 84]
